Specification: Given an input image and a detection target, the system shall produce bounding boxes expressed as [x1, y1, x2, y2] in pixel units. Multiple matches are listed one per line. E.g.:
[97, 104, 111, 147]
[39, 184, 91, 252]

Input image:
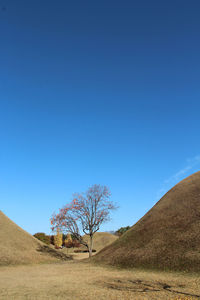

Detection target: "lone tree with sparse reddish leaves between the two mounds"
[51, 184, 117, 257]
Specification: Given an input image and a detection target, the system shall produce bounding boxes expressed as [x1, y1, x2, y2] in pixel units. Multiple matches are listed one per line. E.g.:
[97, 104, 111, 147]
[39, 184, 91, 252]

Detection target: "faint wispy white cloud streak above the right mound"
[157, 155, 200, 199]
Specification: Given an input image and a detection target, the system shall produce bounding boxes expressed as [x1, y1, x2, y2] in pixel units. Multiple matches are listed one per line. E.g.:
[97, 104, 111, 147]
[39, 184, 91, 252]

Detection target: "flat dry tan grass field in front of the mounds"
[0, 261, 200, 300]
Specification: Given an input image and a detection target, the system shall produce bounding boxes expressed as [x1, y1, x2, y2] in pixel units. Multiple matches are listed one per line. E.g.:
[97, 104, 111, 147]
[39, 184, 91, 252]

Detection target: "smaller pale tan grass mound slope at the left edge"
[0, 211, 69, 265]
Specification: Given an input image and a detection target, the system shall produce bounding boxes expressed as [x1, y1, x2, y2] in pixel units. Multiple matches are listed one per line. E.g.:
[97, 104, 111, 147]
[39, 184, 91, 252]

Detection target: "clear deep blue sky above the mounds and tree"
[0, 0, 200, 233]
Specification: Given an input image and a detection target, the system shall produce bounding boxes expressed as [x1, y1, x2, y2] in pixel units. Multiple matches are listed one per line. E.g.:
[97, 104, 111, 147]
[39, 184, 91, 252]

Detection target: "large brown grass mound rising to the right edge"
[93, 172, 200, 272]
